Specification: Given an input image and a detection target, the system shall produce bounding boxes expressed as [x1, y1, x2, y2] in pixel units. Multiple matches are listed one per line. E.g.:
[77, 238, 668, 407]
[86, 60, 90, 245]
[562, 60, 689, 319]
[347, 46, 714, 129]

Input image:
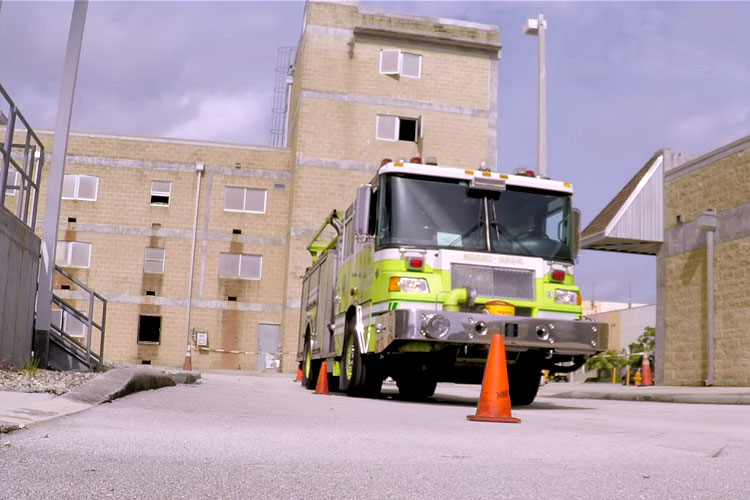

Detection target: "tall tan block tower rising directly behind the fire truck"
[282, 1, 500, 370]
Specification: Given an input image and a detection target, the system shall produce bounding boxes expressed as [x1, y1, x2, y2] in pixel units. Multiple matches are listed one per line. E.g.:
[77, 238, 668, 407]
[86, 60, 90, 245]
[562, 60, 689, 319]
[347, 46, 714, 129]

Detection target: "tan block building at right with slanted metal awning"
[582, 136, 750, 385]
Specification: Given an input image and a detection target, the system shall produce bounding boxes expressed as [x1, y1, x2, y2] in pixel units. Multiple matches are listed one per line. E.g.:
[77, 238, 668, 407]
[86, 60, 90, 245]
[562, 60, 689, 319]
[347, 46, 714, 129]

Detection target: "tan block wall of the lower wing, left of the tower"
[29, 133, 291, 369]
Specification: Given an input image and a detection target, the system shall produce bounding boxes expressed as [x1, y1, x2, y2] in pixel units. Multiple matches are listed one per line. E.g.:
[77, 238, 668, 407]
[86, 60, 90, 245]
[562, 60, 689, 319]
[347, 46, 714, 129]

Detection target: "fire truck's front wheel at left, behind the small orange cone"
[339, 319, 383, 397]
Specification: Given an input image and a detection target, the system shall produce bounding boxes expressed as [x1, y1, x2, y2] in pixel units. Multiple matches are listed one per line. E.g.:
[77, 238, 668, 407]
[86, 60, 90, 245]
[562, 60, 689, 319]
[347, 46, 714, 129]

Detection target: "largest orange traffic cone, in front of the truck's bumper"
[466, 335, 521, 424]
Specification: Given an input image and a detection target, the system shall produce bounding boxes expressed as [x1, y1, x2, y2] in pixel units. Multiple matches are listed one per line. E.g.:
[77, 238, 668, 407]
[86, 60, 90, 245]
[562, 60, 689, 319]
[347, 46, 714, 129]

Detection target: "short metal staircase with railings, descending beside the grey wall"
[47, 266, 107, 371]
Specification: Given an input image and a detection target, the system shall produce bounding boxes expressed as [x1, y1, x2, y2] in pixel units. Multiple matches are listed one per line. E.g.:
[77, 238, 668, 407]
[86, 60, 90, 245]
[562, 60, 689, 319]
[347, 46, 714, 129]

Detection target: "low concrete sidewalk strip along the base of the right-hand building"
[539, 382, 750, 405]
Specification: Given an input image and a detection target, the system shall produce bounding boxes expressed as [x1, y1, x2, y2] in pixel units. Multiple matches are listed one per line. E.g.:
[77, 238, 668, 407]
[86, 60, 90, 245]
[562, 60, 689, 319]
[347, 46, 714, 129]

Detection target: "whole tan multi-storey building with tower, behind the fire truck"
[6, 2, 500, 371]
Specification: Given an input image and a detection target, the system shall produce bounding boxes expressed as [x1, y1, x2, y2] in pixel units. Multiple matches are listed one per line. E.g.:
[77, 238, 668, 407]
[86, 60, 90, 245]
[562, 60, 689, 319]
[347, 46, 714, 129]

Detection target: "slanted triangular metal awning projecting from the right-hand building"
[581, 150, 671, 255]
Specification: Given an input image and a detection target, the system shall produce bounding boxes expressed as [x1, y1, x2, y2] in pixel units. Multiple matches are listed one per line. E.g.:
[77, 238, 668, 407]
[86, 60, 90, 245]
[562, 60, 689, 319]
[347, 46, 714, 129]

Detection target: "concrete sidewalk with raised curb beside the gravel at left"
[0, 367, 201, 434]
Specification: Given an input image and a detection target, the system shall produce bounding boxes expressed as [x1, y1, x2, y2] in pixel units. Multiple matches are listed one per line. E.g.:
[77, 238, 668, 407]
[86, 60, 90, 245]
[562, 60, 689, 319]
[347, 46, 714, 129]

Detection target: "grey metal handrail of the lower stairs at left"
[50, 266, 107, 368]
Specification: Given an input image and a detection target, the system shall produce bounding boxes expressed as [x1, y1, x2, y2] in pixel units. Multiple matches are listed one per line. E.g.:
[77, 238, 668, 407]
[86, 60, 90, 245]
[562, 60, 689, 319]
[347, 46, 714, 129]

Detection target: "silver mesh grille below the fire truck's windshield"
[451, 264, 534, 300]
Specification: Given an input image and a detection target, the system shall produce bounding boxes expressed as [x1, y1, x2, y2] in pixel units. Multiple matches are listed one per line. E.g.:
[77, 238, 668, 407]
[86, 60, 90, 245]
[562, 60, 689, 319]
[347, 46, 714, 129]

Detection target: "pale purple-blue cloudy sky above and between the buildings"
[0, 0, 750, 303]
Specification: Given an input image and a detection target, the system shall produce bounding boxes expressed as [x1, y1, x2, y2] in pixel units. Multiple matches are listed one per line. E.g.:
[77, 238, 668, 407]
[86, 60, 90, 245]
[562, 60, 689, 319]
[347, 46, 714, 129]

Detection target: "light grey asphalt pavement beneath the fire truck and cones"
[0, 371, 750, 500]
